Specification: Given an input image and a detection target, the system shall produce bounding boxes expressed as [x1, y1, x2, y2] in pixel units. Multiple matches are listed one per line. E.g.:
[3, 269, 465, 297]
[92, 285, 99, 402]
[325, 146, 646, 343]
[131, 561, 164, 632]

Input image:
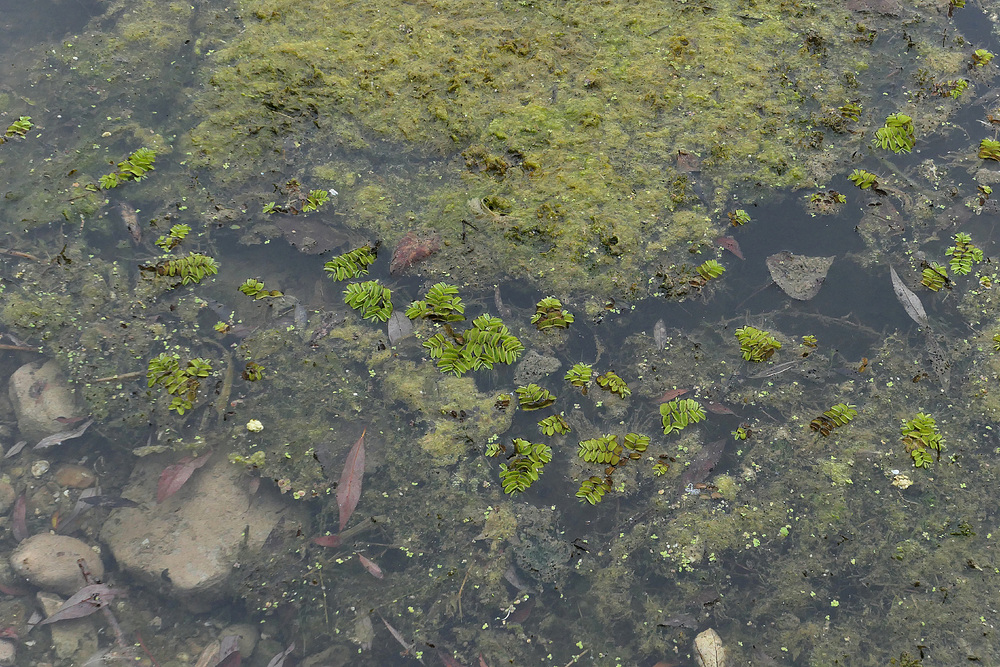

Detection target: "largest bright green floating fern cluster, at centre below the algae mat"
[424, 314, 524, 375]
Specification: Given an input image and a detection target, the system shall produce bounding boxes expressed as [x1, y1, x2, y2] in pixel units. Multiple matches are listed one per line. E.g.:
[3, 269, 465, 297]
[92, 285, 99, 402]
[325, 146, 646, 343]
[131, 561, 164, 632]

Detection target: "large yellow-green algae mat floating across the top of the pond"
[190, 0, 866, 293]
